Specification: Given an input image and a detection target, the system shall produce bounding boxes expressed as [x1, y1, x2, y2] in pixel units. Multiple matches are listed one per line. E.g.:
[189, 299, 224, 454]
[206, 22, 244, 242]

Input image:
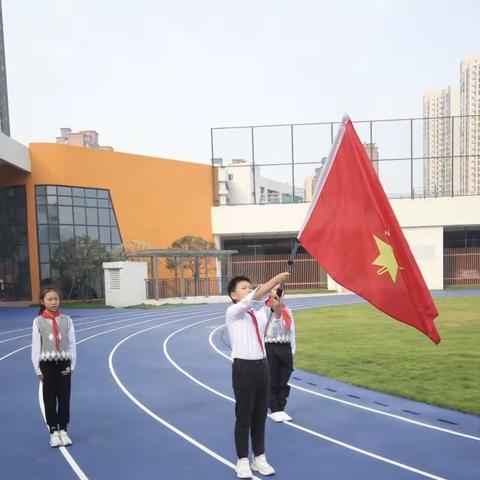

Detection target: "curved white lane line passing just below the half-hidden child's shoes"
[164, 320, 446, 480]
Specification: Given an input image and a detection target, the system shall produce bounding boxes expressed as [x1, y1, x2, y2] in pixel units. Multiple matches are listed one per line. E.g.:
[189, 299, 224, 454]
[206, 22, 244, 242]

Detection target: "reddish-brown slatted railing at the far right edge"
[443, 247, 480, 287]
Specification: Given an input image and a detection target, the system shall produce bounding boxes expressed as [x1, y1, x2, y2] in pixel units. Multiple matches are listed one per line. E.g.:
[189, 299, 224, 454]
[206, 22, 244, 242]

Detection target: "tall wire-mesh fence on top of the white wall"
[210, 115, 480, 205]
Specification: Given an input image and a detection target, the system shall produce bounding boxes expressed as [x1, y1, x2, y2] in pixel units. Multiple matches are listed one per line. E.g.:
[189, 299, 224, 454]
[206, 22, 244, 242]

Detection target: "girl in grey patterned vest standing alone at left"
[32, 288, 77, 447]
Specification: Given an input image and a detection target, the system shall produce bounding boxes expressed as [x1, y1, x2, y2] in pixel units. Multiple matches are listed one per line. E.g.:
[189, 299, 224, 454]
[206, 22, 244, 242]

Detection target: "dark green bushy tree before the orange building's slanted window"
[51, 236, 111, 300]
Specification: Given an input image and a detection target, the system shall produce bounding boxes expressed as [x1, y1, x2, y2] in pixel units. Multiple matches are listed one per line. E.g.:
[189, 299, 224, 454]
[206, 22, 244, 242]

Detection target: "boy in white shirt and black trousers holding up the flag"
[225, 273, 290, 478]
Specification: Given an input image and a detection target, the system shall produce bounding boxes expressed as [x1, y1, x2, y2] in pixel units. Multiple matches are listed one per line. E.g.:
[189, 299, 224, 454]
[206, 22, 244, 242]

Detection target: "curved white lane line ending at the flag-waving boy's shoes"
[108, 316, 260, 480]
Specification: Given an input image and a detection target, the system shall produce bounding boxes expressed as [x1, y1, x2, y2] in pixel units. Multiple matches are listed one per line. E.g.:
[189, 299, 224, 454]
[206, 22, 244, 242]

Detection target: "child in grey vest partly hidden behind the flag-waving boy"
[265, 288, 295, 422]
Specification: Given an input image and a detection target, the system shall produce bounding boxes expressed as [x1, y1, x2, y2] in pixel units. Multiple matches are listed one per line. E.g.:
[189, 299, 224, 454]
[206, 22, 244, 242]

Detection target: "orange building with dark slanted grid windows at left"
[0, 143, 213, 300]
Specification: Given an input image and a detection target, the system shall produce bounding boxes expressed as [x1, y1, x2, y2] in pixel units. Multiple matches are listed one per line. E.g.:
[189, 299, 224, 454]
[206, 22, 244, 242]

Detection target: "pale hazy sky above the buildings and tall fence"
[2, 0, 480, 162]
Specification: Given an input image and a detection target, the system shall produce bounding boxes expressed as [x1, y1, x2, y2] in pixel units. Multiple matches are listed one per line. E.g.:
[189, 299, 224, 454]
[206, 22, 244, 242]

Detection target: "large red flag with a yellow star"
[298, 118, 440, 343]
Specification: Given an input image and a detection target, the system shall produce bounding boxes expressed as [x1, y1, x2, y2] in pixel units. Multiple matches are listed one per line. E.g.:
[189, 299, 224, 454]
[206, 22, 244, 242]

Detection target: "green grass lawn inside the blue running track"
[295, 296, 480, 415]
